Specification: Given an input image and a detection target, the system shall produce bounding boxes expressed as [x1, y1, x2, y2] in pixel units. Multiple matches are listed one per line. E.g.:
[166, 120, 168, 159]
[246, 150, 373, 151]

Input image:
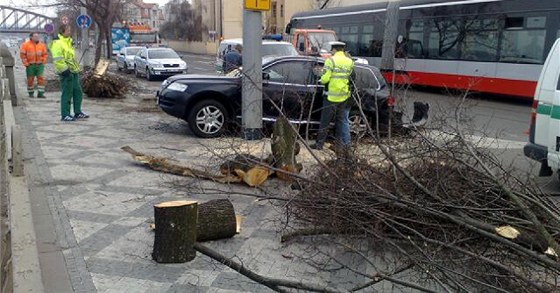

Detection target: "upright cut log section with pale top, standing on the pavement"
[152, 200, 198, 263]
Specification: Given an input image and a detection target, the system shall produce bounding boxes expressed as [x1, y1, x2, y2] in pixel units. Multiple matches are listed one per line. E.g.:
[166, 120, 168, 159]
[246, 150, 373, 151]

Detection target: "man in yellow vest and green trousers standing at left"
[50, 24, 89, 121]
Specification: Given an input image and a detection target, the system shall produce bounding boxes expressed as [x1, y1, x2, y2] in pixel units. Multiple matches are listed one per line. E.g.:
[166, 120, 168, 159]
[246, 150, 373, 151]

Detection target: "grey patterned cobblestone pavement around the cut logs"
[16, 58, 412, 293]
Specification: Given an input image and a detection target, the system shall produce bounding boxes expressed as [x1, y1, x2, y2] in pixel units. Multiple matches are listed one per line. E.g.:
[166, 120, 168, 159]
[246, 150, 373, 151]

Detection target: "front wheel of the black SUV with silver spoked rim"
[187, 100, 228, 138]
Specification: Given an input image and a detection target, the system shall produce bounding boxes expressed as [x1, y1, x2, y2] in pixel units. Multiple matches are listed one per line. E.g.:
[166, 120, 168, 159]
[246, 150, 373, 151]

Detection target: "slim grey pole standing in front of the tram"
[381, 0, 401, 71]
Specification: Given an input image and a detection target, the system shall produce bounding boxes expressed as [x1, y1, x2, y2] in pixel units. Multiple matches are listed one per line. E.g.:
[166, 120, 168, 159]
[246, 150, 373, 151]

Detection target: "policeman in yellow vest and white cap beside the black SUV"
[311, 42, 354, 150]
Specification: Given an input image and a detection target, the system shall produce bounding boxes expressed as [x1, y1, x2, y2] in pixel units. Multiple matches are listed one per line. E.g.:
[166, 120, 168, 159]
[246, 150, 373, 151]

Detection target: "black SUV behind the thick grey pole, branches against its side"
[157, 56, 392, 138]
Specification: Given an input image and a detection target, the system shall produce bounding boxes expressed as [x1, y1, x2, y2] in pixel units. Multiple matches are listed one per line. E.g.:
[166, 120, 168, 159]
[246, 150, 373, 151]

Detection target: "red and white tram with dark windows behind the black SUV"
[286, 0, 560, 98]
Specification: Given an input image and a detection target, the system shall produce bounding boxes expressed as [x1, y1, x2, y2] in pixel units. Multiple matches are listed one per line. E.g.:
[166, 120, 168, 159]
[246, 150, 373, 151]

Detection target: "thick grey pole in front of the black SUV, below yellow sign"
[241, 9, 262, 140]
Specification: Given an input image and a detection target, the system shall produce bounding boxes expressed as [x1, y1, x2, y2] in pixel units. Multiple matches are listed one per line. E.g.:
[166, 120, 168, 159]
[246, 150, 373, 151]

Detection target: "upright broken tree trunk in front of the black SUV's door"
[271, 117, 302, 181]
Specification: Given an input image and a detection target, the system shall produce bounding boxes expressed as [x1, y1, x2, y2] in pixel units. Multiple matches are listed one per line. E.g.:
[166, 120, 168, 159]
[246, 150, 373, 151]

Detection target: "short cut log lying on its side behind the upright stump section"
[196, 199, 237, 242]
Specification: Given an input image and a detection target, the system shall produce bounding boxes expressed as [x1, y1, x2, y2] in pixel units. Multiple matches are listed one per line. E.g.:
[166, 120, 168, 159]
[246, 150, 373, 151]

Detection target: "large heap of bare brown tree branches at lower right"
[283, 94, 560, 292]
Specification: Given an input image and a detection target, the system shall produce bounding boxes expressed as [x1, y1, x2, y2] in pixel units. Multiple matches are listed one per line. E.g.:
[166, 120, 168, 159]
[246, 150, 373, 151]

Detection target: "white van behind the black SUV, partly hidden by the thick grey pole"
[216, 39, 299, 73]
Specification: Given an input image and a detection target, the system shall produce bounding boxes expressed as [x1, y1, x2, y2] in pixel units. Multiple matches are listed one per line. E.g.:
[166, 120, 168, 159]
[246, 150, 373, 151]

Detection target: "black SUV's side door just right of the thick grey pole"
[263, 60, 315, 122]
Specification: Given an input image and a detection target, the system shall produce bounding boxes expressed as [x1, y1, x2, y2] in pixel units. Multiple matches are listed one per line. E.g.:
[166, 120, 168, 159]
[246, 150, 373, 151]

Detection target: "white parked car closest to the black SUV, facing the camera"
[134, 48, 188, 80]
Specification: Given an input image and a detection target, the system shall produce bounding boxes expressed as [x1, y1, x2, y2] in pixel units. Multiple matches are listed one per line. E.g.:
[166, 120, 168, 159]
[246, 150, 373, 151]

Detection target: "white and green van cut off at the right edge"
[523, 39, 560, 178]
